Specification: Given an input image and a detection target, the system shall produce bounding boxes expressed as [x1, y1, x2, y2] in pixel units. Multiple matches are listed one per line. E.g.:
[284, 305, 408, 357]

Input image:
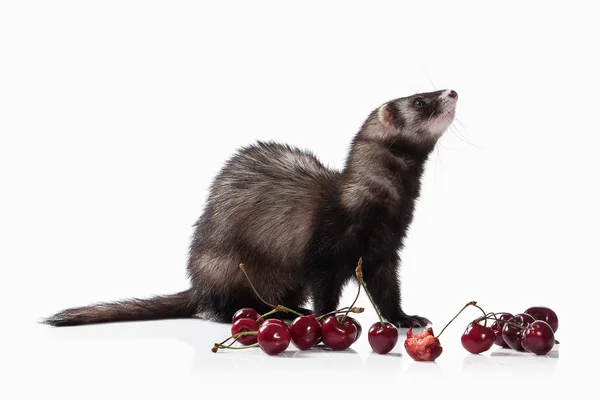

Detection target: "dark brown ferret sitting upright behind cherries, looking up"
[43, 90, 458, 327]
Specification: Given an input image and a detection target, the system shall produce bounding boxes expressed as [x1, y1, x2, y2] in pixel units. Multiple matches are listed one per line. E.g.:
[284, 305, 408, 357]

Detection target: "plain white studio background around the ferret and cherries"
[0, 1, 600, 399]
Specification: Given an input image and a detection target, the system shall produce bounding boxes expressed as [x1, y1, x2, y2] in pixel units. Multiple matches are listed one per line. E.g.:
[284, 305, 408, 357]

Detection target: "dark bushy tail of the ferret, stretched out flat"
[42, 289, 198, 326]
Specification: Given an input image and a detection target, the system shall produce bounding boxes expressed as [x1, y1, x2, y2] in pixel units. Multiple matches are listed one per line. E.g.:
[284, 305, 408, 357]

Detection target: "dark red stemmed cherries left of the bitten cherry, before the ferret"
[212, 258, 398, 355]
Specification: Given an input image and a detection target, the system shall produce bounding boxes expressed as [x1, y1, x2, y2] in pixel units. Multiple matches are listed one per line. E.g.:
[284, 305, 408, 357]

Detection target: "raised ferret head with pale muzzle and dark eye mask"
[364, 90, 458, 144]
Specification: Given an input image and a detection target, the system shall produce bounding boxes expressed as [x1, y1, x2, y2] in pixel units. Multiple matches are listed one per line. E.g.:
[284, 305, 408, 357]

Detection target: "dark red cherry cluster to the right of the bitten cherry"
[461, 306, 558, 355]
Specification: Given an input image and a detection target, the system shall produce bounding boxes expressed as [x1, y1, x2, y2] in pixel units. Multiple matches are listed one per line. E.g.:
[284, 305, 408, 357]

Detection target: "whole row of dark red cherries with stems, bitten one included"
[212, 258, 558, 361]
